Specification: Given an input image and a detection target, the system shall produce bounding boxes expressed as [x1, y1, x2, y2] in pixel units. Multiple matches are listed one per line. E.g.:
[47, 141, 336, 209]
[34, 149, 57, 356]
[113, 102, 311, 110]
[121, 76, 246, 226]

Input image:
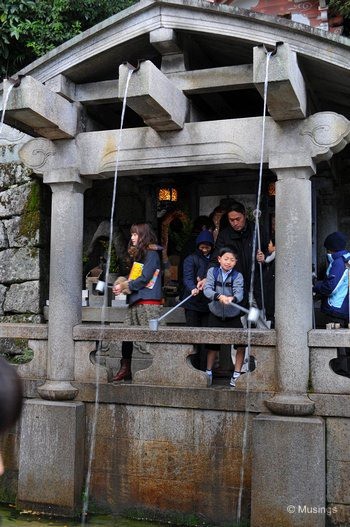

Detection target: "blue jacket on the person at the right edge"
[314, 250, 350, 319]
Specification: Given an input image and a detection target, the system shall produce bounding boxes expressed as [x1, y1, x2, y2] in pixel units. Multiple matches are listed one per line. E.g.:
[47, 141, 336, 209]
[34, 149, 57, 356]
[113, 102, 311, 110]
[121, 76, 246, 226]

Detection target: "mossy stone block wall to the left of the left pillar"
[0, 126, 50, 353]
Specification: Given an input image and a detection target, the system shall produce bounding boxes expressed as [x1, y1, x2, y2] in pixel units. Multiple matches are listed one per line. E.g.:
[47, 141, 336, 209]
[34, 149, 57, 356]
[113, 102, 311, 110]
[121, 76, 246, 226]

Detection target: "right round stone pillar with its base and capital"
[267, 162, 314, 415]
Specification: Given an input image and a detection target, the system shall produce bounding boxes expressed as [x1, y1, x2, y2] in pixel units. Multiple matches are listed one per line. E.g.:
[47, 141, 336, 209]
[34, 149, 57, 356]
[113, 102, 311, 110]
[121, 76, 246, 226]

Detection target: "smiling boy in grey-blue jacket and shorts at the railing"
[204, 247, 244, 388]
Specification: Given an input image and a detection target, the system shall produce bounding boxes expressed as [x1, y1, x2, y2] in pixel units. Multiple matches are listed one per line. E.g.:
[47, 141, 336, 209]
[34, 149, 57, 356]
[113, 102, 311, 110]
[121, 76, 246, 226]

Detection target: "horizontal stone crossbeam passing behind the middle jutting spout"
[46, 64, 254, 105]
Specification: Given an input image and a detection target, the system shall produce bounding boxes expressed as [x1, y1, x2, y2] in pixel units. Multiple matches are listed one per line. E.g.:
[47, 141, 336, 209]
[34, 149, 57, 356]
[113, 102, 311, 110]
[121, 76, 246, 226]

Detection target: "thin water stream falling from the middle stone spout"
[81, 68, 135, 526]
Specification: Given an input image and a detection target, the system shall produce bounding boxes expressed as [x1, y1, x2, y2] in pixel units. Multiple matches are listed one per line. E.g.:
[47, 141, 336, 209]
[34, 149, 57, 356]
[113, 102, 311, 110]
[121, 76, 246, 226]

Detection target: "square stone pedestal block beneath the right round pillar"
[250, 414, 327, 527]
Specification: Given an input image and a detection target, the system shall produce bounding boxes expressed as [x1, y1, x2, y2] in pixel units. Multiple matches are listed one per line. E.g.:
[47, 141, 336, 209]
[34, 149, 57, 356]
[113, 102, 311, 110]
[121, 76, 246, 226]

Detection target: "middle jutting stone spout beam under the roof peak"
[118, 60, 189, 132]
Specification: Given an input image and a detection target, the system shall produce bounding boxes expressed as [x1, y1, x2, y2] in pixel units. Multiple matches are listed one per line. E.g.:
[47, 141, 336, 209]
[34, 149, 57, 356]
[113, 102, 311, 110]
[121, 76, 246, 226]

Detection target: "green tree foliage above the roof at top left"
[0, 0, 136, 77]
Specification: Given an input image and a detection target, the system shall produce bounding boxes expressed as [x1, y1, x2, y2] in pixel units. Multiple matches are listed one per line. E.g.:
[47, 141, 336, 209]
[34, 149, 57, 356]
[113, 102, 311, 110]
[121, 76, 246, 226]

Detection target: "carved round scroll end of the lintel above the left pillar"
[19, 138, 56, 174]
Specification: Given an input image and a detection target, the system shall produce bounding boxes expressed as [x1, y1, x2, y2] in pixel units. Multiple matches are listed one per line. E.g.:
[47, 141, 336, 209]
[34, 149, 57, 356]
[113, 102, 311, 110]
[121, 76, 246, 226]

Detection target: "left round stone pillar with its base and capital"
[38, 169, 87, 400]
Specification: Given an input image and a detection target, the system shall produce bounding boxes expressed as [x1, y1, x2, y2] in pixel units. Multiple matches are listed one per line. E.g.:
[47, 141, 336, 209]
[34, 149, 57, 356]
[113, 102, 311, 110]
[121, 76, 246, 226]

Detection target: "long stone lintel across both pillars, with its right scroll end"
[76, 112, 350, 178]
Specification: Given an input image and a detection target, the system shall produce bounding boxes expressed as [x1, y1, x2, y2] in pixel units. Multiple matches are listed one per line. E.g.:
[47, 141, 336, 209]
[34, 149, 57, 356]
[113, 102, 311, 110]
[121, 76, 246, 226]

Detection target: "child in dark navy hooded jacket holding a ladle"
[183, 230, 214, 370]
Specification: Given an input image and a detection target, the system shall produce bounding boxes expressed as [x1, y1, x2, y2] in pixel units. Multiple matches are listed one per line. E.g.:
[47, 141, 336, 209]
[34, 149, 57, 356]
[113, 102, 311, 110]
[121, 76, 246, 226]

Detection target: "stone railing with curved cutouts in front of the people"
[0, 323, 350, 394]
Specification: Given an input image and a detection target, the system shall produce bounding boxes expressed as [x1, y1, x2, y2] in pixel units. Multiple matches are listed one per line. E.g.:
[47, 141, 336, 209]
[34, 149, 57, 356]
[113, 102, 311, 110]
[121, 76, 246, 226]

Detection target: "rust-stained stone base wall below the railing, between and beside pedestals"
[0, 385, 350, 526]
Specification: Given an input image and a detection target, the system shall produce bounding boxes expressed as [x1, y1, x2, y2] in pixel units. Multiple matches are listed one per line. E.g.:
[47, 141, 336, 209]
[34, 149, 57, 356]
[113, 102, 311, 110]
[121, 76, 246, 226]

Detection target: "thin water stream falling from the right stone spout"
[237, 51, 274, 524]
